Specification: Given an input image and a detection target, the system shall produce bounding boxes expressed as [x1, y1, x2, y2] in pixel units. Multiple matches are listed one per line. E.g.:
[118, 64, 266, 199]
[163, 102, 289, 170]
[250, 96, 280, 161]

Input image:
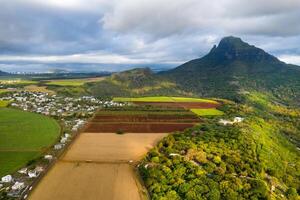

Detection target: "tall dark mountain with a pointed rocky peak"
[158, 36, 300, 103]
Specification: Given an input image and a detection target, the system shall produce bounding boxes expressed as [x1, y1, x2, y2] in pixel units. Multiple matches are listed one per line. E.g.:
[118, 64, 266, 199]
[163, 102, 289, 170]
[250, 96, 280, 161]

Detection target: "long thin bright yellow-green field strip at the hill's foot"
[113, 96, 218, 104]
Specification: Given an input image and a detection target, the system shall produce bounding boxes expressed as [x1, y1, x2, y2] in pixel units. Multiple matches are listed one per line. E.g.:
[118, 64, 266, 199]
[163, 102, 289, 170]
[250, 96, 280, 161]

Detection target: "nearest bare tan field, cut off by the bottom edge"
[30, 161, 142, 200]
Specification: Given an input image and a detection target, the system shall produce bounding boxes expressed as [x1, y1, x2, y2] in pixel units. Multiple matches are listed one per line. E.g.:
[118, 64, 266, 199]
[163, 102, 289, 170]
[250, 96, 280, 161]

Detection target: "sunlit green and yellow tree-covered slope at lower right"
[139, 92, 300, 200]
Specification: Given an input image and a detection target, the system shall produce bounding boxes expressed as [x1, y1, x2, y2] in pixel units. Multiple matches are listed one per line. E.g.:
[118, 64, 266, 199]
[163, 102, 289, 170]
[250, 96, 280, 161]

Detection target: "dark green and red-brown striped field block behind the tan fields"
[85, 106, 200, 133]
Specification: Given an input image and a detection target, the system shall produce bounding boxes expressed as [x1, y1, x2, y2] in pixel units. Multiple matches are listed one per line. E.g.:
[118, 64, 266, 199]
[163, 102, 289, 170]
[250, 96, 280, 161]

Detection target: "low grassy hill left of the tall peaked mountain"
[85, 68, 188, 97]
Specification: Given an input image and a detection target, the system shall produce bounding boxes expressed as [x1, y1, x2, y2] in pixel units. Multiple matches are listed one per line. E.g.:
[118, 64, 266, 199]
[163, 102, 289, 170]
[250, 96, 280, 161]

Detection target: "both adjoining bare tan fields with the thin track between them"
[29, 133, 167, 200]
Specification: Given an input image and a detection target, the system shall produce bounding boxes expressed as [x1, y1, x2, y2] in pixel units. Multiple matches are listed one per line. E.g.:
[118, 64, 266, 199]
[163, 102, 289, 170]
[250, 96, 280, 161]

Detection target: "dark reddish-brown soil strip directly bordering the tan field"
[84, 122, 196, 133]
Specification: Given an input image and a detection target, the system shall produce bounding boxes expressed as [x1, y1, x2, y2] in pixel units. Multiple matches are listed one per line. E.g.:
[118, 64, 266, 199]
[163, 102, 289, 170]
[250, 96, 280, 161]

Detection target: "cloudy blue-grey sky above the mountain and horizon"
[0, 0, 300, 72]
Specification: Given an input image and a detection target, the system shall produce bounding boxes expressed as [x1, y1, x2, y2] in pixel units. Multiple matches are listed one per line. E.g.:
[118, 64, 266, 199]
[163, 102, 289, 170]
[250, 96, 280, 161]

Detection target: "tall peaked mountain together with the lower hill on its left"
[81, 36, 300, 105]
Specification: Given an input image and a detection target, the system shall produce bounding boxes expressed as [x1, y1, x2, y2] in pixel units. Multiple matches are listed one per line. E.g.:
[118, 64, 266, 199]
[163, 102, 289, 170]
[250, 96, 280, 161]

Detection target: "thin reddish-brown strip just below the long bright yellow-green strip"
[133, 102, 220, 109]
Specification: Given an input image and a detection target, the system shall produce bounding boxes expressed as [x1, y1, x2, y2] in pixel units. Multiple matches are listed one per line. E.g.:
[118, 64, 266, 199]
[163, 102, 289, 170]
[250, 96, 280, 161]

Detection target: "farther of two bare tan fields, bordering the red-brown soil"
[62, 133, 167, 162]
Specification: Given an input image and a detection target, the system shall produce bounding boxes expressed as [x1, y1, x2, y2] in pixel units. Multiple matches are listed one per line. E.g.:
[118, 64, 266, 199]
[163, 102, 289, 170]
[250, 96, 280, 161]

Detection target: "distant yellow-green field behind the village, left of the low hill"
[45, 77, 104, 86]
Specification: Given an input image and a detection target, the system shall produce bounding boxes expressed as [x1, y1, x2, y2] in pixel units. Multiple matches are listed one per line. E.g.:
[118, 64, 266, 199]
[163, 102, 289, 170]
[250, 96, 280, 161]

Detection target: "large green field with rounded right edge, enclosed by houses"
[0, 108, 60, 176]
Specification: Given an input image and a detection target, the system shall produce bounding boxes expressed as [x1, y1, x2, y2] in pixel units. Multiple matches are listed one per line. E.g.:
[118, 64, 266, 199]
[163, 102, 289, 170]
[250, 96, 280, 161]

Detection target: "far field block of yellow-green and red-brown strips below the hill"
[113, 96, 223, 116]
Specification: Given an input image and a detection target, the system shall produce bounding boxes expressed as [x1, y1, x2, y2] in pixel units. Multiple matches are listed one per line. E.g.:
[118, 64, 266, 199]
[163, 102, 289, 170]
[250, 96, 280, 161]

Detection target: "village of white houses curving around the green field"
[0, 91, 125, 199]
